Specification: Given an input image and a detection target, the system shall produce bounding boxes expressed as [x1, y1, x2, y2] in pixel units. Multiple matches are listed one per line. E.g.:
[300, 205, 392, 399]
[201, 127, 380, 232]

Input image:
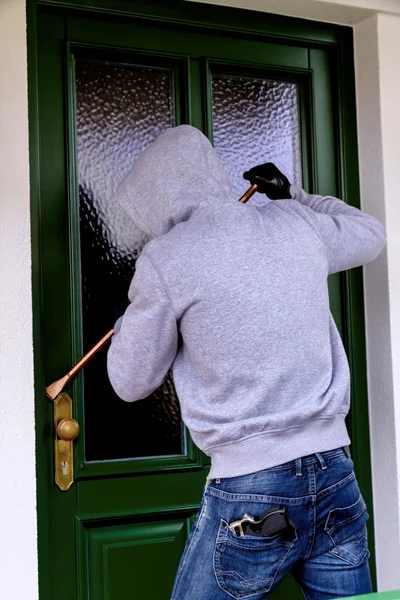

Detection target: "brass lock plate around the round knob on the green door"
[53, 392, 79, 492]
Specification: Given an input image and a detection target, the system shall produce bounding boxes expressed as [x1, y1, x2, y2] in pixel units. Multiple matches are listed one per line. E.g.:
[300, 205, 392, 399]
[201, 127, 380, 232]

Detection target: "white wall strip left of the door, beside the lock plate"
[0, 0, 38, 600]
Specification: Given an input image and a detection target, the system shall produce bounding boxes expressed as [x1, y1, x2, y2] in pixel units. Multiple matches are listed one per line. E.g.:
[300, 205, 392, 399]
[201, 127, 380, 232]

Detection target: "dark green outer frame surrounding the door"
[27, 0, 375, 600]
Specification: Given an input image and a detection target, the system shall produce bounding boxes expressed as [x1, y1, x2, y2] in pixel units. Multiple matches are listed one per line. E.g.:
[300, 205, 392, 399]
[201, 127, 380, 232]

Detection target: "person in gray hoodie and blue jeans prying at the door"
[108, 125, 385, 600]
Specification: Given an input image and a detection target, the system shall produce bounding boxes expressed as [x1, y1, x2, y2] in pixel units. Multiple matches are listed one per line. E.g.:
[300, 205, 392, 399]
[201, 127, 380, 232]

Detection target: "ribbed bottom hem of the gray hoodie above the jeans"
[207, 415, 350, 479]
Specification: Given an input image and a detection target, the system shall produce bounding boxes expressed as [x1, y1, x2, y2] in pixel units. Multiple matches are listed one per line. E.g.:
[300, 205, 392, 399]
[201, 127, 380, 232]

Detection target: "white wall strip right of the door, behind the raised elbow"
[355, 15, 400, 590]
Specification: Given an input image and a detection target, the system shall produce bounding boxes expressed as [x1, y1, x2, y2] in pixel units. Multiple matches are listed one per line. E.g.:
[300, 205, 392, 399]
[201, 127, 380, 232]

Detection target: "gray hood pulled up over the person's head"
[117, 125, 233, 237]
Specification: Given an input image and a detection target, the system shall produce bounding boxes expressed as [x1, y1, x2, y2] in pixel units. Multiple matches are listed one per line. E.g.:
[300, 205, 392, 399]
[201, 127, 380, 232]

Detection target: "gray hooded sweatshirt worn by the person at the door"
[108, 125, 385, 478]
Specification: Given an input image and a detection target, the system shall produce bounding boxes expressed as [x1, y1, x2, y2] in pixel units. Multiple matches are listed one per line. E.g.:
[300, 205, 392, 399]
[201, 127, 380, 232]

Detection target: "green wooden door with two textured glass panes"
[31, 3, 374, 600]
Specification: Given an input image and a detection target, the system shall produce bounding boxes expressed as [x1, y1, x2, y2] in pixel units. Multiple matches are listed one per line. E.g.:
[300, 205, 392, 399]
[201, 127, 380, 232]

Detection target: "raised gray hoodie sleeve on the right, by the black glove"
[290, 185, 386, 274]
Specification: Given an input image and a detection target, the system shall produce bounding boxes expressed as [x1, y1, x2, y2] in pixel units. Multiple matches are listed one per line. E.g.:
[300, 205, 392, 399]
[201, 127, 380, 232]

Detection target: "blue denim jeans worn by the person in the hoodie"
[171, 448, 371, 600]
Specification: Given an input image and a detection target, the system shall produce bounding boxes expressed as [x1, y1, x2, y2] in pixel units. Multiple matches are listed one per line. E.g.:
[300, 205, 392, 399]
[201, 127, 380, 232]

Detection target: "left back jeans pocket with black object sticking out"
[214, 519, 297, 598]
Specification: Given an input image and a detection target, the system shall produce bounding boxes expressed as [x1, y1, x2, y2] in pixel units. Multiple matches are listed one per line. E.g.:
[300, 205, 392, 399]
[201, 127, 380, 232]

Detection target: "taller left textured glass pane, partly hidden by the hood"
[75, 60, 185, 461]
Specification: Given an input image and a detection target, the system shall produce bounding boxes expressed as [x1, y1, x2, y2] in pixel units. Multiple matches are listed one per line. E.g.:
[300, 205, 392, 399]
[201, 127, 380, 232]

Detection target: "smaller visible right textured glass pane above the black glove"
[212, 73, 302, 201]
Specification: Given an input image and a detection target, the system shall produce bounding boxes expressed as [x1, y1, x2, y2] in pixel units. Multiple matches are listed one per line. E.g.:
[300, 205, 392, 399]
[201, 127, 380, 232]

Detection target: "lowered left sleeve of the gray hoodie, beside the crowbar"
[107, 254, 178, 402]
